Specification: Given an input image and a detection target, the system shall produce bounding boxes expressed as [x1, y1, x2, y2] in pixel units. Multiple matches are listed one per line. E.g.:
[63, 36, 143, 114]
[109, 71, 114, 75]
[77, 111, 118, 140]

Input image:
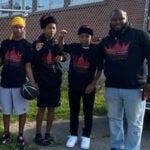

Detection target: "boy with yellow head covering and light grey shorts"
[0, 17, 34, 148]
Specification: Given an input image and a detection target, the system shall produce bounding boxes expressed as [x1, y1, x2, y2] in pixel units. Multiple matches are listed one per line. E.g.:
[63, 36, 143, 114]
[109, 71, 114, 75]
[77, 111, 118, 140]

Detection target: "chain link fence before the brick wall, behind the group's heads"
[0, 0, 146, 89]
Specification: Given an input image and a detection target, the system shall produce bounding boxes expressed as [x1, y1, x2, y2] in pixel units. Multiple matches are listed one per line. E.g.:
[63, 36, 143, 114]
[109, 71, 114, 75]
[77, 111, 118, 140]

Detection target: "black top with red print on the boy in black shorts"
[32, 34, 62, 88]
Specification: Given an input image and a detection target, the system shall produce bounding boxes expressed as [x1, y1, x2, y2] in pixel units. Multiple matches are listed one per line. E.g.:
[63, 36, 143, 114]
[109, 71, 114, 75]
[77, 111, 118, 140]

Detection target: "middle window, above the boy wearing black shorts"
[37, 0, 64, 11]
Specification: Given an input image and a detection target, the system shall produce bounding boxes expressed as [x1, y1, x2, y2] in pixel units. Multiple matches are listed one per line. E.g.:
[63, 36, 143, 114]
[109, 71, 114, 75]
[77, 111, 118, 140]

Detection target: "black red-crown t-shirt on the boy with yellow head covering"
[0, 39, 32, 88]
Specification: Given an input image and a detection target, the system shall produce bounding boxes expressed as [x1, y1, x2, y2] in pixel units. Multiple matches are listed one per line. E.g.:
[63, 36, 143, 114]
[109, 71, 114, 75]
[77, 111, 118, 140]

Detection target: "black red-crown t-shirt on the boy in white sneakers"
[64, 43, 103, 90]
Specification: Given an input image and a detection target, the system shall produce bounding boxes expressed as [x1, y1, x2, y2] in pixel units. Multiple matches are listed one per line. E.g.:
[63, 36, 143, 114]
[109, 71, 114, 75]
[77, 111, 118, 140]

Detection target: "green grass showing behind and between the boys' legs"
[0, 90, 107, 150]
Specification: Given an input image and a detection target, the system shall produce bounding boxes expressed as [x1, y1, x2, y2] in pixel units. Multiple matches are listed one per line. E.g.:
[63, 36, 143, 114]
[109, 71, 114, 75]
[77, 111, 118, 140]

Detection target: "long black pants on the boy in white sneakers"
[69, 89, 95, 137]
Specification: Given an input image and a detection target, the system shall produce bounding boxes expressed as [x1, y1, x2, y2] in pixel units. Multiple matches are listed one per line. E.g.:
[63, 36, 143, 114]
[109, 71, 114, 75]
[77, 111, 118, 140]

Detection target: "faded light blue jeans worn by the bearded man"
[105, 88, 146, 150]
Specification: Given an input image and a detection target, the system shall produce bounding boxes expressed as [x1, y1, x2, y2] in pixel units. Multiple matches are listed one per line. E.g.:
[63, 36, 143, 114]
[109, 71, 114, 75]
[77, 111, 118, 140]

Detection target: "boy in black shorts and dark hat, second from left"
[33, 14, 62, 146]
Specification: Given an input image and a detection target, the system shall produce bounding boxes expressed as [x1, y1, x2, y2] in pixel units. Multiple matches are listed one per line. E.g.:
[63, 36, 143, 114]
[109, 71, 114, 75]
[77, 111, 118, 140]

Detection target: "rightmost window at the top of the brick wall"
[70, 0, 104, 6]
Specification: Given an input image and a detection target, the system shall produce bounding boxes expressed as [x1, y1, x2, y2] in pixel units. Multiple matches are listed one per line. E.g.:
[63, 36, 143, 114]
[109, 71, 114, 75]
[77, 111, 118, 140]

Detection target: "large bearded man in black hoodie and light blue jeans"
[100, 9, 150, 150]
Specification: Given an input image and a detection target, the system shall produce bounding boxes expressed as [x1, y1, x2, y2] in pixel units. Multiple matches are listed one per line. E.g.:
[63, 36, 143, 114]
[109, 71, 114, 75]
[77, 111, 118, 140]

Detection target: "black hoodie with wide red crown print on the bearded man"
[100, 24, 150, 89]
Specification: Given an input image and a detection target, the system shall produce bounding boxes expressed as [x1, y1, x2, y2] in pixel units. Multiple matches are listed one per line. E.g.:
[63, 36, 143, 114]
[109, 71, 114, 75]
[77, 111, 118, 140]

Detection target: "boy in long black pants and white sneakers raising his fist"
[59, 25, 102, 149]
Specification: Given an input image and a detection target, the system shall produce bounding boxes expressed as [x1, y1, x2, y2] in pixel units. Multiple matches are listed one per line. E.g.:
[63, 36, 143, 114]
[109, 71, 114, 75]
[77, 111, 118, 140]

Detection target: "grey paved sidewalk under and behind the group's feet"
[11, 117, 150, 150]
